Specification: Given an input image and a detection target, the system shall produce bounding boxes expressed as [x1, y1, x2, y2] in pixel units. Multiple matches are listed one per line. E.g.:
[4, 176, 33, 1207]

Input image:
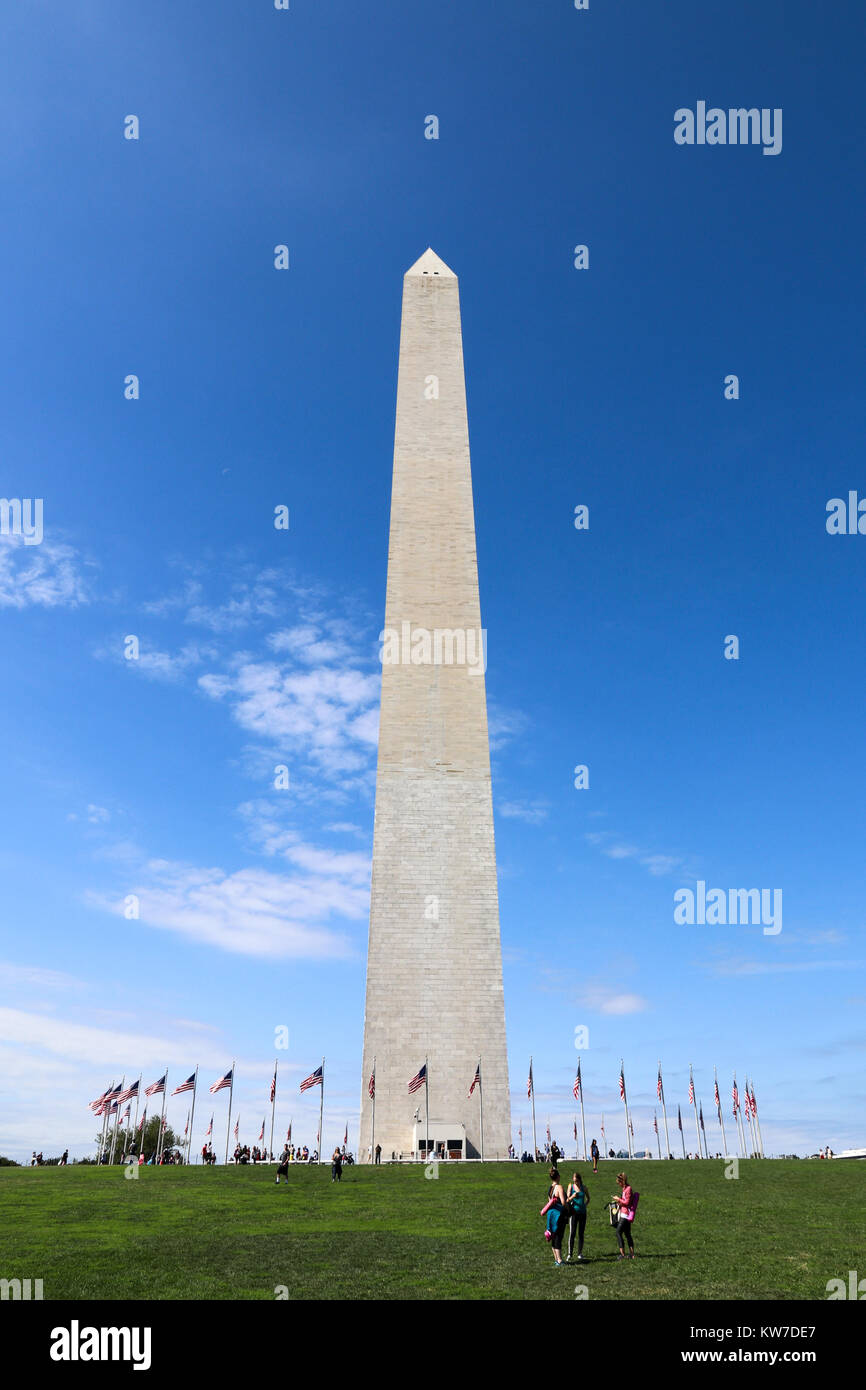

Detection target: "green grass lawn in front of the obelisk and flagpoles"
[0, 1161, 866, 1300]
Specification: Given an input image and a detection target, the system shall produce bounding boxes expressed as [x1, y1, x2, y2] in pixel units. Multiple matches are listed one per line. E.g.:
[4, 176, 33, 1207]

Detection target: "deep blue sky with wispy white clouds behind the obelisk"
[0, 0, 866, 1158]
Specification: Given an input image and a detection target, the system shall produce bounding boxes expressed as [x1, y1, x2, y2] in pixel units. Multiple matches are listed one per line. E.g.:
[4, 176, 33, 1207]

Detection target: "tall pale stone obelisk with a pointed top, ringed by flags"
[360, 249, 512, 1161]
